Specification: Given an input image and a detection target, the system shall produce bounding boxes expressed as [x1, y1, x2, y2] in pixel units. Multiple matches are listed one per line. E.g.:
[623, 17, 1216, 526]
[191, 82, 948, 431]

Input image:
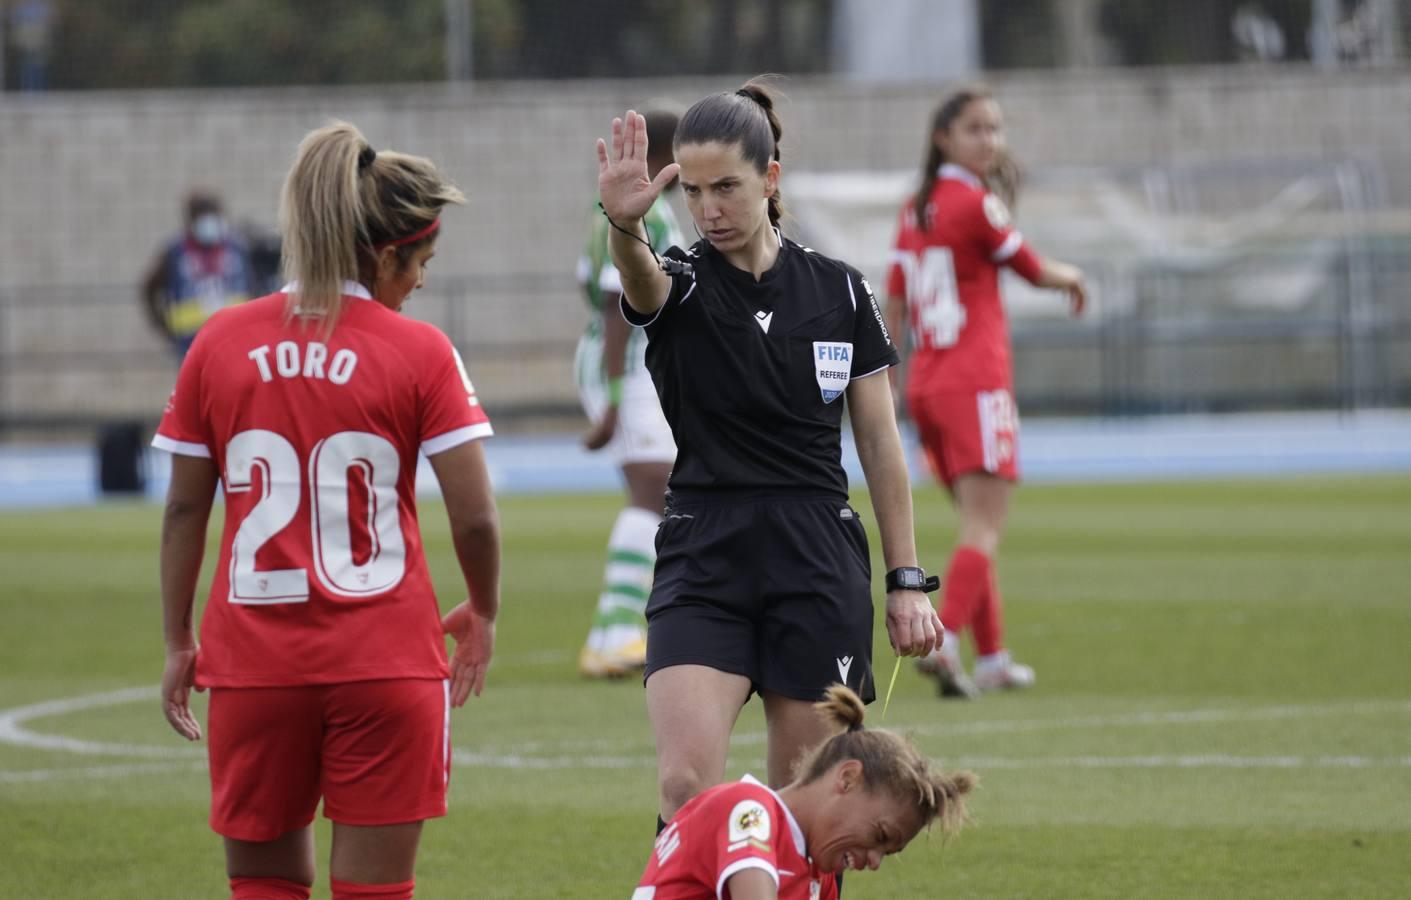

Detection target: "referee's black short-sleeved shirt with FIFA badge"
[622, 229, 899, 501]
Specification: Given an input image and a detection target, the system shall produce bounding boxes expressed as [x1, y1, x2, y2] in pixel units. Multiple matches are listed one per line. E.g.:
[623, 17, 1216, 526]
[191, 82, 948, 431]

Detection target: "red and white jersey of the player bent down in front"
[632, 774, 838, 900]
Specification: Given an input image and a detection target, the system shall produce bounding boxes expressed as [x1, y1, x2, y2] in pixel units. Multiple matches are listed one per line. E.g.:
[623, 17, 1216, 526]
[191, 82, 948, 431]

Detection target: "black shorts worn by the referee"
[645, 492, 876, 703]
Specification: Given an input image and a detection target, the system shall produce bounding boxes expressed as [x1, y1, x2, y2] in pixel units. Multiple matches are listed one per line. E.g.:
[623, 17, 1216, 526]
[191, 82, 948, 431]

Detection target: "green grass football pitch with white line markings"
[0, 478, 1411, 900]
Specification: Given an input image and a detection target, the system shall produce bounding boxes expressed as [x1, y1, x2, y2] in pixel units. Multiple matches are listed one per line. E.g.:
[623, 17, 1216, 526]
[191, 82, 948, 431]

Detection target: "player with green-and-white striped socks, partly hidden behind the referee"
[573, 110, 683, 677]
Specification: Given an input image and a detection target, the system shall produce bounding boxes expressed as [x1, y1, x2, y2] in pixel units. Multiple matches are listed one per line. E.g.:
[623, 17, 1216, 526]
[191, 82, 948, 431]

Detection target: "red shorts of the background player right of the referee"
[907, 388, 1019, 487]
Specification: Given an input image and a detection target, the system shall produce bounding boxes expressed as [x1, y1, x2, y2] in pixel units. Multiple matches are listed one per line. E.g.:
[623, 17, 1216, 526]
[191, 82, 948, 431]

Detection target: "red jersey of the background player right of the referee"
[888, 164, 1041, 391]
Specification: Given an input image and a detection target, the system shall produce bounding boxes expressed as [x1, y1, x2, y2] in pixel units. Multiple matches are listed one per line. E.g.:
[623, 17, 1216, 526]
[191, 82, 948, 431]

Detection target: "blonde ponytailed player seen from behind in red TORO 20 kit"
[152, 123, 499, 900]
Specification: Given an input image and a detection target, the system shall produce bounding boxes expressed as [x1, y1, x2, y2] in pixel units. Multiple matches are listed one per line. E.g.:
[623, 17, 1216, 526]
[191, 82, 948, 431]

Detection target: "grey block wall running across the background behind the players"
[0, 68, 1411, 426]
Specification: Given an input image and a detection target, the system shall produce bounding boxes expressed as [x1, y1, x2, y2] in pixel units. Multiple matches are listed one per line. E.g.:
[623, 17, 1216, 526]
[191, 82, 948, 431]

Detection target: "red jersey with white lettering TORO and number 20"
[152, 282, 491, 687]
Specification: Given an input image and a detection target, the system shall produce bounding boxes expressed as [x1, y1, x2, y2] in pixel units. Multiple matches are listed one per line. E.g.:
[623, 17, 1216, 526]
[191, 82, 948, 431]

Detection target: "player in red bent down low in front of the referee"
[632, 684, 976, 900]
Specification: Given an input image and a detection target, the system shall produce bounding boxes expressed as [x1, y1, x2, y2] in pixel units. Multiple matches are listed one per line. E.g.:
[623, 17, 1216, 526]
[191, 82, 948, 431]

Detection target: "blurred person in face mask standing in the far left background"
[143, 190, 261, 363]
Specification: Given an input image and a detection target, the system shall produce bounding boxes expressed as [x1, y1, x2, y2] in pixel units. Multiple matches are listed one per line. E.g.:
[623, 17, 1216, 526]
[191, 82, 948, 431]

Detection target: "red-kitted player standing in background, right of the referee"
[888, 89, 1086, 697]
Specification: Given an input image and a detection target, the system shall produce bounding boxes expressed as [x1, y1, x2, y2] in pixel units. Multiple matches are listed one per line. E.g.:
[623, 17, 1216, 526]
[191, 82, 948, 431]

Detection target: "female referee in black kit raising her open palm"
[598, 83, 941, 828]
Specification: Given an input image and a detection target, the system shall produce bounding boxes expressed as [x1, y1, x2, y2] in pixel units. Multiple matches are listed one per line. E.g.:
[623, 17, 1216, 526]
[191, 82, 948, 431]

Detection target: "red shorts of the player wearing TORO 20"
[206, 679, 450, 841]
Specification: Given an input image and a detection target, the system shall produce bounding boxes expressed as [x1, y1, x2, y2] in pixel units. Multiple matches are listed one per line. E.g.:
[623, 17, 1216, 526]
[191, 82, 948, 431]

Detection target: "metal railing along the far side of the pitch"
[0, 241, 1411, 436]
